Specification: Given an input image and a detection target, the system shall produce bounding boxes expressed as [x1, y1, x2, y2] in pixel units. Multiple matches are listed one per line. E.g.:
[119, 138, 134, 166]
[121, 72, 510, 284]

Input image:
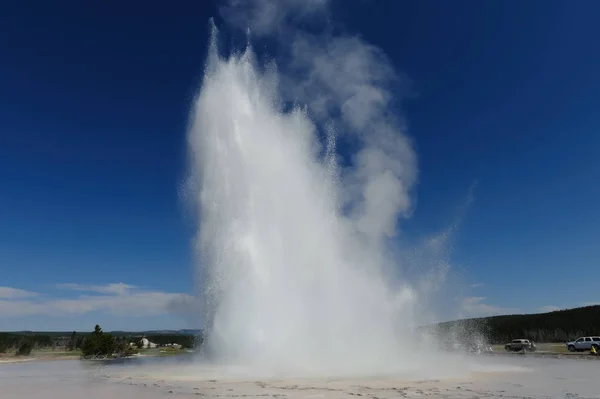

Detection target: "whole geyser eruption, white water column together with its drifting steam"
[183, 0, 460, 374]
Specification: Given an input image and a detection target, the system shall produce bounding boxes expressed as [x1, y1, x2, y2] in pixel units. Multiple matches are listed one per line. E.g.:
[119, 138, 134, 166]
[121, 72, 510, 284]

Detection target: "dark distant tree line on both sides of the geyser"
[5, 305, 600, 355]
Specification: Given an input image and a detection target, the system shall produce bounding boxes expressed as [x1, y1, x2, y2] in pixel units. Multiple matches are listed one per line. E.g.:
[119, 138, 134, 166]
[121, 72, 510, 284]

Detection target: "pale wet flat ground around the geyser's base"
[0, 356, 600, 399]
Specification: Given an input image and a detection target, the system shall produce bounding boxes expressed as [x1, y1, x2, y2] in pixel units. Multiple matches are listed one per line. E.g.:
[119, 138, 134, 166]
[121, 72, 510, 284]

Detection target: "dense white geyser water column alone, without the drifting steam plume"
[189, 29, 426, 375]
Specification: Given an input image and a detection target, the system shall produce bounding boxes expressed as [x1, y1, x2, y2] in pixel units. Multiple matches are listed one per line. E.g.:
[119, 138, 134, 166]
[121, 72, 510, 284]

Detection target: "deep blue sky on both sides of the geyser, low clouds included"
[0, 0, 600, 330]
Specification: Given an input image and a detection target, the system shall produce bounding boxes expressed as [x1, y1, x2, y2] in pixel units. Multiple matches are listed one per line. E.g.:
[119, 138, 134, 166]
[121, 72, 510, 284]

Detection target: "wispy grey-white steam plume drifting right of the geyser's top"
[221, 0, 418, 244]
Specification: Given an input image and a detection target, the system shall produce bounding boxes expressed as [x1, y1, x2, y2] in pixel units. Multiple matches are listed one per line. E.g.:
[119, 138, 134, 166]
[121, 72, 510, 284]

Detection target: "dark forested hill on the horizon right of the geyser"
[430, 305, 600, 344]
